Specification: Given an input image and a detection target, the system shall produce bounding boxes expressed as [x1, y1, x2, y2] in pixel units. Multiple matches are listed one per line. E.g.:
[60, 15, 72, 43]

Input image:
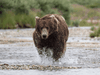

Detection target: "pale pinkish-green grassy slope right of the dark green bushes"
[71, 4, 100, 26]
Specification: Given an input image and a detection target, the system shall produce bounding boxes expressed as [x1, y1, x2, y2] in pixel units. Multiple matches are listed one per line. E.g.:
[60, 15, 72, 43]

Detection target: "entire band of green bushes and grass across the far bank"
[0, 0, 100, 29]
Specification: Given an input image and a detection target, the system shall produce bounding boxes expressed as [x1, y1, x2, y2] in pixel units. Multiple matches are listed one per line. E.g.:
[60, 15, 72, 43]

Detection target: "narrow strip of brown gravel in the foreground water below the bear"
[0, 64, 82, 71]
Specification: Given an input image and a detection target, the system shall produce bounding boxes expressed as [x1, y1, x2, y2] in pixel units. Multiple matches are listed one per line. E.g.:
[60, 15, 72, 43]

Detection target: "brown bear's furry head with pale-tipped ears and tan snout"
[35, 15, 59, 39]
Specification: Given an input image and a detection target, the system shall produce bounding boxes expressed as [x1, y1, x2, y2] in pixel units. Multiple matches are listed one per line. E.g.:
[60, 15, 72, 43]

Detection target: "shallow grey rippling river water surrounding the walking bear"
[0, 27, 100, 75]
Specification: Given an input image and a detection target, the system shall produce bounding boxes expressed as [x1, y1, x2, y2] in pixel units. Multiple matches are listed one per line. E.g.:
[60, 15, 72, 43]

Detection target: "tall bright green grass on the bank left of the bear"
[0, 11, 37, 29]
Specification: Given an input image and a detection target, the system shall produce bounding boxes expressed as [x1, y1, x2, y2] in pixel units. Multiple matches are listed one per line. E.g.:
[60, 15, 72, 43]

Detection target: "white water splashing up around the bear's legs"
[34, 47, 68, 66]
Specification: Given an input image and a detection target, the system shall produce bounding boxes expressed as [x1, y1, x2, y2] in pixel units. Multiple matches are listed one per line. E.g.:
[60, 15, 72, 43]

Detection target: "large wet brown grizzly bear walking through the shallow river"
[33, 14, 69, 61]
